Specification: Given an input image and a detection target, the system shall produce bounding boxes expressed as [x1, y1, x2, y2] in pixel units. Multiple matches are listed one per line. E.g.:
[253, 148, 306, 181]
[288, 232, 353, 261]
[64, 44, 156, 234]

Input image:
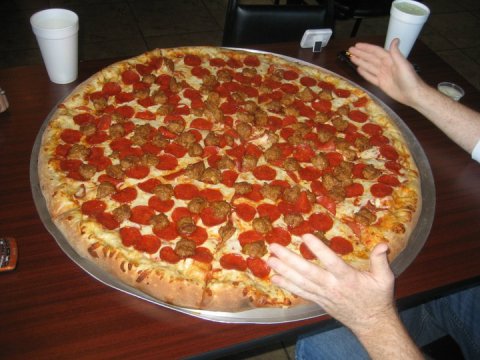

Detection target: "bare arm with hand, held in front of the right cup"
[349, 39, 480, 153]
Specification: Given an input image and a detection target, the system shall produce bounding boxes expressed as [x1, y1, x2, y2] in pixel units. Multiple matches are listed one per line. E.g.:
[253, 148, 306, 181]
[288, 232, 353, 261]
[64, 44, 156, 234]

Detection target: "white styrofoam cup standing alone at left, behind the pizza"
[30, 9, 78, 84]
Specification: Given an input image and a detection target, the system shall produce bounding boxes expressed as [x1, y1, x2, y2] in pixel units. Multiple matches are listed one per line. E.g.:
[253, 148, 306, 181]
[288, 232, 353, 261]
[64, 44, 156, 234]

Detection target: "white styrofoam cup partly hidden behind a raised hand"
[385, 0, 430, 57]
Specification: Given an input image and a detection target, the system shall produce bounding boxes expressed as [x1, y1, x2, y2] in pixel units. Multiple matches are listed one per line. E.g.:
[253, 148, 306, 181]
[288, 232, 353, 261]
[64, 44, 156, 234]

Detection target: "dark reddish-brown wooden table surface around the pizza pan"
[0, 38, 480, 359]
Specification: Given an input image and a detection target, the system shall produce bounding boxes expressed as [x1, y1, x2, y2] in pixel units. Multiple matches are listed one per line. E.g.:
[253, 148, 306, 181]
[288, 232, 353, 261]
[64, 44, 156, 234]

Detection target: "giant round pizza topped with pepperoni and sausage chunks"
[38, 47, 421, 311]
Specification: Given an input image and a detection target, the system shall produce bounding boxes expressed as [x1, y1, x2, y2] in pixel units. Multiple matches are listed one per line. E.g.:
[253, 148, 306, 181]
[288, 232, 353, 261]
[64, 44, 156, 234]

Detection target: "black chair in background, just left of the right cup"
[335, 0, 393, 37]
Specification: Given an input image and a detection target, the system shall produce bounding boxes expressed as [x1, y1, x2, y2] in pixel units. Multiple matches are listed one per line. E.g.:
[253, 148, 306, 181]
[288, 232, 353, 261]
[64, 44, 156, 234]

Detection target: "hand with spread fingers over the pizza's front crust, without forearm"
[268, 235, 396, 334]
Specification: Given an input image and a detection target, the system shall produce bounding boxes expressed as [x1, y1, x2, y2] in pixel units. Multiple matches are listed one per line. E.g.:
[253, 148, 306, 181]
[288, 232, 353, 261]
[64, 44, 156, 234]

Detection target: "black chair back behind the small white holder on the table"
[222, 0, 334, 47]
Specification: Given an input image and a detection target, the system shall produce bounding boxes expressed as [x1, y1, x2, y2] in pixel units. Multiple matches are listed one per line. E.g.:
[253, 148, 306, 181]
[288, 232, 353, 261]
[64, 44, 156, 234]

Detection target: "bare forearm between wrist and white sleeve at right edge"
[408, 84, 480, 153]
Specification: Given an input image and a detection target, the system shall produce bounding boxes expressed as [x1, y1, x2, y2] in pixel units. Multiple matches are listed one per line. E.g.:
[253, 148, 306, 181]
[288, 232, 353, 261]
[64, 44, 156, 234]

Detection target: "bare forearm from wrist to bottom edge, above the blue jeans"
[353, 309, 423, 360]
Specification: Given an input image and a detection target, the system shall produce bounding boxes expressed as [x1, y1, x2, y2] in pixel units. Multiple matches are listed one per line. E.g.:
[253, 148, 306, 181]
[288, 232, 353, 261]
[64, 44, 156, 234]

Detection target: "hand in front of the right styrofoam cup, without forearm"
[348, 39, 426, 107]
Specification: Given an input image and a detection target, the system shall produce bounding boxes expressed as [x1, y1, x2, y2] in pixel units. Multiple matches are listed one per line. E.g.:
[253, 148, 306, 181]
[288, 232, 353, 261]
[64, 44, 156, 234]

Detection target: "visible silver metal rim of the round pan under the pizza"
[30, 49, 435, 324]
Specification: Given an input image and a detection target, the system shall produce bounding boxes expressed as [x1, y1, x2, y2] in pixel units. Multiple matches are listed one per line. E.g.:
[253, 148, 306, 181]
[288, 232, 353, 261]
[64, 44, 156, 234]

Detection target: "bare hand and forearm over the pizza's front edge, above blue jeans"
[268, 235, 422, 359]
